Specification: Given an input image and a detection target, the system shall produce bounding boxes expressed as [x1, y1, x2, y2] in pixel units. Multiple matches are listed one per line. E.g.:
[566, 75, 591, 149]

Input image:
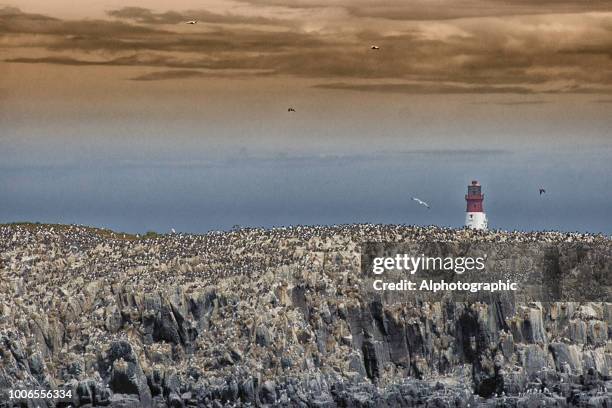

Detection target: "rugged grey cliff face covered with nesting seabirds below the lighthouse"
[0, 225, 612, 407]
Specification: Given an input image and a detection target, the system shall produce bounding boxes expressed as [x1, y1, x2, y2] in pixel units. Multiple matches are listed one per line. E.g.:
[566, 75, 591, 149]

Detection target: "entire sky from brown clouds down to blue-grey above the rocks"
[0, 0, 612, 230]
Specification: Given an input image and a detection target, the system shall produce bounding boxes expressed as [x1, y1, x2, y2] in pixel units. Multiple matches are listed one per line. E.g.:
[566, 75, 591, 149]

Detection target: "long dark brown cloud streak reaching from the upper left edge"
[0, 8, 321, 54]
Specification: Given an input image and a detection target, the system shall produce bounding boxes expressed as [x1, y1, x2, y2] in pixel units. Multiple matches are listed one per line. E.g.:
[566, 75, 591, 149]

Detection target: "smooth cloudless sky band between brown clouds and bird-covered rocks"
[0, 79, 612, 234]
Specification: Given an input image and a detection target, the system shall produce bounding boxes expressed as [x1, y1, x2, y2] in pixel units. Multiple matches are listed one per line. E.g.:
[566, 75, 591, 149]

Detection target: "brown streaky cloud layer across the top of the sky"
[0, 0, 612, 94]
